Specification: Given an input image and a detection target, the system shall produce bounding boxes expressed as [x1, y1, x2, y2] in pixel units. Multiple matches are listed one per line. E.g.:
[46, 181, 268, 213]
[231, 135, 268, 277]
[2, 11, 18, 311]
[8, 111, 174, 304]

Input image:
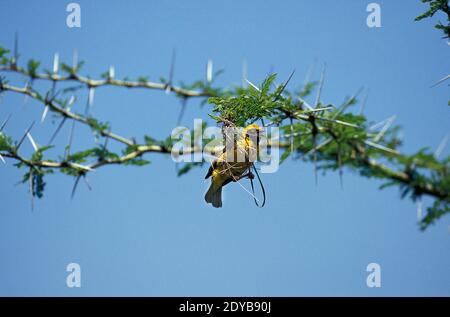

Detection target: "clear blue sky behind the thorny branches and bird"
[0, 0, 450, 296]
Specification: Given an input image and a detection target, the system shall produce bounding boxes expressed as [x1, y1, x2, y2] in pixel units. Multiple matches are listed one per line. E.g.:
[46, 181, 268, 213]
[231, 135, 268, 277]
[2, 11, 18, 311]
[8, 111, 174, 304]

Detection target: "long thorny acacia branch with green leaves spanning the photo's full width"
[0, 44, 450, 226]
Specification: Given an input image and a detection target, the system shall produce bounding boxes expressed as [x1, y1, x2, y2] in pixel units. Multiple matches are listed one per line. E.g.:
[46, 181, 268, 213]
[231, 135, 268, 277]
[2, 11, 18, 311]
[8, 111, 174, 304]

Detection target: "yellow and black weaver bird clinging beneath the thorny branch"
[205, 124, 262, 208]
